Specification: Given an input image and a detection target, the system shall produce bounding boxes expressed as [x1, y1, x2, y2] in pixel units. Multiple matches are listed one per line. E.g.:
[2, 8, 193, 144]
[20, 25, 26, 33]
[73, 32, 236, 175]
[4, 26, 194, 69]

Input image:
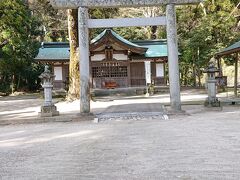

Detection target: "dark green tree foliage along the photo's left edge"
[0, 0, 40, 91]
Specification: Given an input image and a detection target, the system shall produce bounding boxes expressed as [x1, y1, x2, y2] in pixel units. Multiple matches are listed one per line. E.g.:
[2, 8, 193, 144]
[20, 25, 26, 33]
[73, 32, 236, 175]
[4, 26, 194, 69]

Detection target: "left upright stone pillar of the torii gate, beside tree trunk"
[78, 7, 90, 114]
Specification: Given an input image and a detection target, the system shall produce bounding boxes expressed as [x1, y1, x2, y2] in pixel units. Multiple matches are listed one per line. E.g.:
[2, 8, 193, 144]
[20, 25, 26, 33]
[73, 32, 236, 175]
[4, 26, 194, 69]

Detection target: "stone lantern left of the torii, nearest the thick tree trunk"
[39, 65, 59, 117]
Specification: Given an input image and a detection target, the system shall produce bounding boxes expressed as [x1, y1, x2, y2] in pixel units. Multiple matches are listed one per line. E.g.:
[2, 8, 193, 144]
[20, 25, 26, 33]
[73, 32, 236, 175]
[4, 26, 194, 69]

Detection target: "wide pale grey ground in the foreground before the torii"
[0, 106, 240, 180]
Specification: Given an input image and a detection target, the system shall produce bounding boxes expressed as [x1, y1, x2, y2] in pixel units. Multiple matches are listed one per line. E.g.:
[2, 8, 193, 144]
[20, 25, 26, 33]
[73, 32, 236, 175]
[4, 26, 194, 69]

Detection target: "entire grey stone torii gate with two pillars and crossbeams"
[50, 0, 203, 114]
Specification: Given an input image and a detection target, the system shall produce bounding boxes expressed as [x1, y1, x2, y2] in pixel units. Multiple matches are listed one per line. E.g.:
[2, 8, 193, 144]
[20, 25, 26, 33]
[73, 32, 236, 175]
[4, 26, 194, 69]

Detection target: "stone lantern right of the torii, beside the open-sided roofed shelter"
[204, 59, 220, 107]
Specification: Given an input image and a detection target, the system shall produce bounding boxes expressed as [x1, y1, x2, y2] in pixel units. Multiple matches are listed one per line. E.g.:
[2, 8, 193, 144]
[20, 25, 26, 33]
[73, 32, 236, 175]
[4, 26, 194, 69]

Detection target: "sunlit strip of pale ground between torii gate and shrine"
[0, 90, 206, 125]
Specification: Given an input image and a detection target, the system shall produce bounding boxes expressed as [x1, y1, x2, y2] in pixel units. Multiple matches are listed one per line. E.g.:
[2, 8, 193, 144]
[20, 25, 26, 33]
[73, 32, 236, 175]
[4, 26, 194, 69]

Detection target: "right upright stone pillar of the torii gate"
[166, 4, 181, 111]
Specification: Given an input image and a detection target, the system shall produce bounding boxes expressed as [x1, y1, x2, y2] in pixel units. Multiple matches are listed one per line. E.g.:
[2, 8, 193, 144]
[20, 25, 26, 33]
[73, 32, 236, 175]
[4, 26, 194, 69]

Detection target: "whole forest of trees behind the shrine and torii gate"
[0, 0, 240, 98]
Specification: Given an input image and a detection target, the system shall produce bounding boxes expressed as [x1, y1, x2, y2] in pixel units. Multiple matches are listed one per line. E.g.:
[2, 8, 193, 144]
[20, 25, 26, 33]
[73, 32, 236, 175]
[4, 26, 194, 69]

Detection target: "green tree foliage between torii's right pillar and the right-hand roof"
[177, 0, 237, 86]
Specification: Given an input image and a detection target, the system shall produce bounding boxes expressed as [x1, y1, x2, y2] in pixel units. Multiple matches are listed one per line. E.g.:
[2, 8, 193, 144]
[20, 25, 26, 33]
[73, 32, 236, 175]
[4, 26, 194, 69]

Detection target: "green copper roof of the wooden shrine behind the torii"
[35, 29, 168, 61]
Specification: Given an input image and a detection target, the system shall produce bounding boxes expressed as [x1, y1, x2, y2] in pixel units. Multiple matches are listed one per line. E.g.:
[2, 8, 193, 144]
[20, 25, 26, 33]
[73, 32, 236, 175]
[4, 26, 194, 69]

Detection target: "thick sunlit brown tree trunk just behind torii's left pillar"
[67, 9, 80, 100]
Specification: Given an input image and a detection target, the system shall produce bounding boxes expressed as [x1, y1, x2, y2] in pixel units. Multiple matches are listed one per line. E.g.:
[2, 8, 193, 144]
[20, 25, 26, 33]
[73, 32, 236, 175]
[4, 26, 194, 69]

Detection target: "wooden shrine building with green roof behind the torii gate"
[35, 29, 167, 89]
